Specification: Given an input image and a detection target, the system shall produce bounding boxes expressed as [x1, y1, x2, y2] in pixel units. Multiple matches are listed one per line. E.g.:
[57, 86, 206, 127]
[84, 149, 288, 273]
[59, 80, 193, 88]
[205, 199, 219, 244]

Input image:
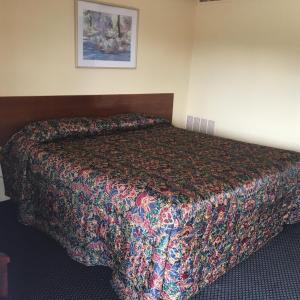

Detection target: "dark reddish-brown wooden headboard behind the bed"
[0, 94, 174, 145]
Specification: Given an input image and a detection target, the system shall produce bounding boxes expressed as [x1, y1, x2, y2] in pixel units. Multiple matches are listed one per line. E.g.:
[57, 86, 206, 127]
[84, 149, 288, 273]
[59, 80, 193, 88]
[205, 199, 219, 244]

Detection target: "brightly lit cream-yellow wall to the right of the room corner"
[187, 0, 300, 151]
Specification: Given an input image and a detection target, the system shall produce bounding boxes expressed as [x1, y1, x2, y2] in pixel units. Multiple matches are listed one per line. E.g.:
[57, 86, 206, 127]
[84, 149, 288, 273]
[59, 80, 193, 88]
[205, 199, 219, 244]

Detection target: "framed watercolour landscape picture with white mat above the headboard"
[75, 0, 138, 68]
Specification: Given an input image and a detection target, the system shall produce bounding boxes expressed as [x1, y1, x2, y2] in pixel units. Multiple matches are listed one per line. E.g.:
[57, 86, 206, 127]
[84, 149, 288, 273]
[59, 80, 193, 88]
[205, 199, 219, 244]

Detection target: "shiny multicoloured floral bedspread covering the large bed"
[3, 115, 300, 299]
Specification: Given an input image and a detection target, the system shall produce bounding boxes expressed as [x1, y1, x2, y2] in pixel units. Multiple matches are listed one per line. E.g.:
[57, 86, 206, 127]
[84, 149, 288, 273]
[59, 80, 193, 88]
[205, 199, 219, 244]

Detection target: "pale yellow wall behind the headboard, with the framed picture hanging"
[0, 0, 196, 126]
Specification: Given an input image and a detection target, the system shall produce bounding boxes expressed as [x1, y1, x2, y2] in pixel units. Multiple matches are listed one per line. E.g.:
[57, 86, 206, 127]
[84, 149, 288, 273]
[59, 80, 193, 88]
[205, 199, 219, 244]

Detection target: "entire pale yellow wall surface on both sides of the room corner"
[0, 0, 300, 151]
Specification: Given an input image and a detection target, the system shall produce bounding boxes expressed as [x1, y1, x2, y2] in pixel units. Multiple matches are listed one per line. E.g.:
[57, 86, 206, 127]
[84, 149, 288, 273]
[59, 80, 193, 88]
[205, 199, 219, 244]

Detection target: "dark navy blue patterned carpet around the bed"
[0, 201, 300, 300]
